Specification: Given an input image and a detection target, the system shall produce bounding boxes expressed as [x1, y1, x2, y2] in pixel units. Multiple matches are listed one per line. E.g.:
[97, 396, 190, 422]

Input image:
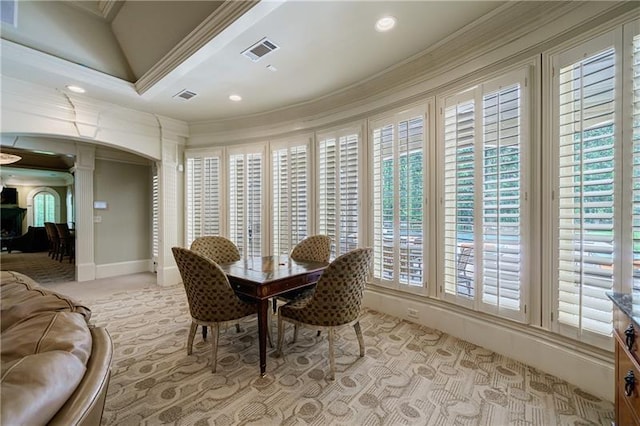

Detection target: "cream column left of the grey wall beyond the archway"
[73, 145, 96, 281]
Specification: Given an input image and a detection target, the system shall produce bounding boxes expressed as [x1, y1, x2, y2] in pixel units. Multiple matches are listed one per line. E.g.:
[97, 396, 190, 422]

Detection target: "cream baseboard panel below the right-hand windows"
[364, 286, 615, 401]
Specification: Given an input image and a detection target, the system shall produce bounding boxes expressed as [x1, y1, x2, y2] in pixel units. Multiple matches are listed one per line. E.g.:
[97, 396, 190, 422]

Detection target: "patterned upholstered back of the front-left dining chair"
[171, 247, 247, 322]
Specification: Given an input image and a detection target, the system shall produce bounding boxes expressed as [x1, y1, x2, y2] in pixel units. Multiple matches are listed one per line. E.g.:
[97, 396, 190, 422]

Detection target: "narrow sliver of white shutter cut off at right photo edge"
[625, 30, 640, 290]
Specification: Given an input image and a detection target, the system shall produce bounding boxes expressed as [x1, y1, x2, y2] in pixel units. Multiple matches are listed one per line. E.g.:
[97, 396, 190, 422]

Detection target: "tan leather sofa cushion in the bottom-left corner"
[0, 312, 92, 424]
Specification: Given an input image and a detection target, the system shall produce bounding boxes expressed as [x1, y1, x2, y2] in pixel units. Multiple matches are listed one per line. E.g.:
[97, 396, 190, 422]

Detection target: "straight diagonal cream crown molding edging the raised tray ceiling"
[135, 0, 259, 95]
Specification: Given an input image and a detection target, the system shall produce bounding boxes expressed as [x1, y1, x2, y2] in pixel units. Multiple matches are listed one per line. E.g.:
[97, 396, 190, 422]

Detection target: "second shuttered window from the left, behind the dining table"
[229, 145, 265, 256]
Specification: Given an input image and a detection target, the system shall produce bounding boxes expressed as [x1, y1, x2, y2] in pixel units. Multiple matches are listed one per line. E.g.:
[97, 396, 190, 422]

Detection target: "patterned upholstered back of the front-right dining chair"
[304, 247, 373, 326]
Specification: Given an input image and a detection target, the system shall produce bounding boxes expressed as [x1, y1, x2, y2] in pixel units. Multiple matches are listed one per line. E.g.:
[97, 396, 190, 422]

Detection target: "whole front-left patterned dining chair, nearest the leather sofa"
[171, 247, 271, 373]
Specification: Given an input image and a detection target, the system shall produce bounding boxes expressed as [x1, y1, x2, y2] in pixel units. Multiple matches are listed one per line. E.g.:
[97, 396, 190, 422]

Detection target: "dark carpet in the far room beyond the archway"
[0, 251, 76, 284]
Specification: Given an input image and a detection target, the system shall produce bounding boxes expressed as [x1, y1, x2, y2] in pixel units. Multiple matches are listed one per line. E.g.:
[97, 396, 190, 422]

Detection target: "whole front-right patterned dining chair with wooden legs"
[276, 248, 373, 380]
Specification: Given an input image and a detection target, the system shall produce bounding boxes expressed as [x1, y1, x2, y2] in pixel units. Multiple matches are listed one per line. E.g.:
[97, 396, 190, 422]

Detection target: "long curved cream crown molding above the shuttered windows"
[190, 1, 634, 137]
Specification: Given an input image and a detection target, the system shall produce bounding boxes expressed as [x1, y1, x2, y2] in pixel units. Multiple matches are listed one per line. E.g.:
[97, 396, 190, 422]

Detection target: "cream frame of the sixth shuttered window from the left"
[436, 66, 536, 324]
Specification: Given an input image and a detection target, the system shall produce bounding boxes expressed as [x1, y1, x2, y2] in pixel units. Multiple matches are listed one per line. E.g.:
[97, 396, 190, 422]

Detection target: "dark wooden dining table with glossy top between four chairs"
[220, 256, 328, 376]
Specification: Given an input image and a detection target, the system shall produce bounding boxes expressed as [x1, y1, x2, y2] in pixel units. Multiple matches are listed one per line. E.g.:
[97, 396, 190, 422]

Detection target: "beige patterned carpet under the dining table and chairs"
[85, 287, 614, 426]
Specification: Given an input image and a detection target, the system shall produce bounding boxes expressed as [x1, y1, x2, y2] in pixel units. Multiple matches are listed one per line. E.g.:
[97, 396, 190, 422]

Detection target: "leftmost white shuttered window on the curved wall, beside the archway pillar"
[185, 151, 221, 246]
